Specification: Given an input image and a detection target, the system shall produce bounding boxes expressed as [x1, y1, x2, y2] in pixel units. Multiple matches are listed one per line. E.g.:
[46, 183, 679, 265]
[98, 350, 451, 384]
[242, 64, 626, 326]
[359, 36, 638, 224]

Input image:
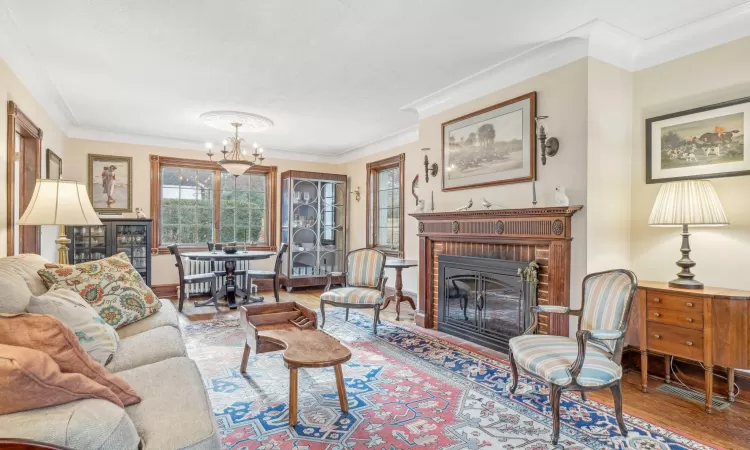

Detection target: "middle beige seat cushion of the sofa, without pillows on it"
[107, 327, 187, 372]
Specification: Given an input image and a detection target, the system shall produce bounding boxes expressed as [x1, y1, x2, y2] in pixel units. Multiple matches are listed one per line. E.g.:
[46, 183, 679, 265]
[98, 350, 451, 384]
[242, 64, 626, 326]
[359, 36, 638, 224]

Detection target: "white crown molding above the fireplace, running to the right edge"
[401, 9, 750, 119]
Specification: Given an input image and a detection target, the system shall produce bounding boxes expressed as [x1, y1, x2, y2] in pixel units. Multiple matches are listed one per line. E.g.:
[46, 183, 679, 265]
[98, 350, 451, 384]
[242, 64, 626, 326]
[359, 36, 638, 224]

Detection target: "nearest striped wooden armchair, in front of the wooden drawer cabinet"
[509, 270, 638, 445]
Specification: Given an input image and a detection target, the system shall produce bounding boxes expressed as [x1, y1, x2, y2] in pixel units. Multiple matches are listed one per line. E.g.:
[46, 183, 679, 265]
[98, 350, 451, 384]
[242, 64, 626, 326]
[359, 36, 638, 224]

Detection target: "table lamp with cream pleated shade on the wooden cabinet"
[648, 180, 729, 289]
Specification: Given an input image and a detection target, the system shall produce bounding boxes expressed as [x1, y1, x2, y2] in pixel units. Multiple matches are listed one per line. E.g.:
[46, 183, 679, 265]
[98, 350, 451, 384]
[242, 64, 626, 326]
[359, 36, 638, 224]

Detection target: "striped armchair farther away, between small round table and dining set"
[320, 248, 388, 334]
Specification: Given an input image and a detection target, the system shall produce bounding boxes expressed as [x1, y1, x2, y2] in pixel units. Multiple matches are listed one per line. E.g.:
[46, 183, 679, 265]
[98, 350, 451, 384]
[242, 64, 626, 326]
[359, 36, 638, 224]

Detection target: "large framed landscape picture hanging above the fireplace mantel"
[442, 92, 536, 191]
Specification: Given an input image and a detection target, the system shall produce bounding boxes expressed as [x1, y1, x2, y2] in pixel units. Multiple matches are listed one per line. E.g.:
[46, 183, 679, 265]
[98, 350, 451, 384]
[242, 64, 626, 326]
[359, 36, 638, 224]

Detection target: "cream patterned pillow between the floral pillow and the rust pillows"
[29, 289, 120, 364]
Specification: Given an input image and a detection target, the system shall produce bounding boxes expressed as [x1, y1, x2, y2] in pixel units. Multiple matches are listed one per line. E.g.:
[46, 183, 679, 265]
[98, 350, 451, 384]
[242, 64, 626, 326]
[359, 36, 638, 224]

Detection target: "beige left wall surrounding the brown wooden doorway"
[0, 59, 69, 260]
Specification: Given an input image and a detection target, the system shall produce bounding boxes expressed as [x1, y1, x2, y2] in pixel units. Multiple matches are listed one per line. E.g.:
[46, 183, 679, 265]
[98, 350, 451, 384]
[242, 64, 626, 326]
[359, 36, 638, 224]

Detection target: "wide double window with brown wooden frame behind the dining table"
[151, 155, 276, 253]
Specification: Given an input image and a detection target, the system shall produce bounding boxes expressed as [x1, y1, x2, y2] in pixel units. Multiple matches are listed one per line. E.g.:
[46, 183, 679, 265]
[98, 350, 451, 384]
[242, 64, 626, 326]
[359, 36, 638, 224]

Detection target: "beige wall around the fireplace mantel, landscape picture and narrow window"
[346, 59, 588, 312]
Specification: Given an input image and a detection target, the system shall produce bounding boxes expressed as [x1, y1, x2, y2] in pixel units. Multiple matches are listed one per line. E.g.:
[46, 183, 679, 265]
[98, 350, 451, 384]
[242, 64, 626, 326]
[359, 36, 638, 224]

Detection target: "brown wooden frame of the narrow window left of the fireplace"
[366, 153, 406, 258]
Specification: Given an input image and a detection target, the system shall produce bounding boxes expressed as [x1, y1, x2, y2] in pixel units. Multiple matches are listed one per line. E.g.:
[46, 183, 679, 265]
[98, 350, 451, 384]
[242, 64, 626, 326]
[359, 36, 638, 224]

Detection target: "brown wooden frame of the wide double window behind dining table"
[150, 155, 278, 255]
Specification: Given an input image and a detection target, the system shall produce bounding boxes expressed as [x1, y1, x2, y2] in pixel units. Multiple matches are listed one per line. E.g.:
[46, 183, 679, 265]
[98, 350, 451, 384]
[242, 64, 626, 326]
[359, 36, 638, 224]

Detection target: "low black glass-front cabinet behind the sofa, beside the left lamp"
[65, 217, 151, 286]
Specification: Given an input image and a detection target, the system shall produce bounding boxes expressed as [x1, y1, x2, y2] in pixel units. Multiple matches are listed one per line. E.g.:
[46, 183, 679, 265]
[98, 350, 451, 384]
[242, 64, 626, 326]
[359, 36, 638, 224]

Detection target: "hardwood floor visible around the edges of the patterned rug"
[173, 289, 750, 449]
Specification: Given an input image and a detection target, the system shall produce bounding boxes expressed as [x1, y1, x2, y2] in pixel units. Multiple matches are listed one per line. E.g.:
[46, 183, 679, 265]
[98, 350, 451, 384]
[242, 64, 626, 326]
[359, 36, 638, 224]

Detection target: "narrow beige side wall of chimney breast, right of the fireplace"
[588, 58, 633, 272]
